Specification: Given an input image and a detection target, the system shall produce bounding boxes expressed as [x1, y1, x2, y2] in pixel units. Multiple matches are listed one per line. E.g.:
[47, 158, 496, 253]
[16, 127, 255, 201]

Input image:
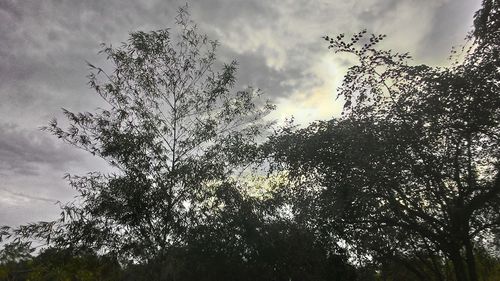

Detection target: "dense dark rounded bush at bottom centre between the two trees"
[177, 178, 356, 281]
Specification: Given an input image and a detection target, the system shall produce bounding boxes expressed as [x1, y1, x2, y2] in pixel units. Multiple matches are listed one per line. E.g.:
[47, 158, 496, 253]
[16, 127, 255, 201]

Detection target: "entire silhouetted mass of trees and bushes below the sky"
[0, 0, 500, 281]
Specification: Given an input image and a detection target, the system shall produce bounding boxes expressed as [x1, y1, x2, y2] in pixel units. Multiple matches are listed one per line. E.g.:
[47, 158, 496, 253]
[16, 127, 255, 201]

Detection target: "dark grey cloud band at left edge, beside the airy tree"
[0, 123, 79, 176]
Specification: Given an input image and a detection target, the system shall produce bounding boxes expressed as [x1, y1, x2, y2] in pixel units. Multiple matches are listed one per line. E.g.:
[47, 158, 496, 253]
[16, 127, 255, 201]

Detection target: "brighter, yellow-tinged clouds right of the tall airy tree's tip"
[189, 0, 473, 122]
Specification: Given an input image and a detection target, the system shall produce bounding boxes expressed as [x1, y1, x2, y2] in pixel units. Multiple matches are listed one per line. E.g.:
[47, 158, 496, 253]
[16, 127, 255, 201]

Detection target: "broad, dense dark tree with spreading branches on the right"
[271, 1, 500, 281]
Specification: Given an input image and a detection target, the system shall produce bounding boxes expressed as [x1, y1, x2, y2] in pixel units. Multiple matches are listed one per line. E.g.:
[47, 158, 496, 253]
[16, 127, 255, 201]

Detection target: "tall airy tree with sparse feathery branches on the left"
[1, 5, 273, 263]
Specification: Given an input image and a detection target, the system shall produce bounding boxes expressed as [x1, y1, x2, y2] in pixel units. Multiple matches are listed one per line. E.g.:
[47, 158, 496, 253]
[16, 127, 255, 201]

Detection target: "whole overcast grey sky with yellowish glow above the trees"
[0, 0, 480, 226]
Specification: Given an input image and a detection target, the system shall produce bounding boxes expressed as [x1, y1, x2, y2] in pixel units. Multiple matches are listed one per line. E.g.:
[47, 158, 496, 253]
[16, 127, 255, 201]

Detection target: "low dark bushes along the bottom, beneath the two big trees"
[0, 182, 356, 281]
